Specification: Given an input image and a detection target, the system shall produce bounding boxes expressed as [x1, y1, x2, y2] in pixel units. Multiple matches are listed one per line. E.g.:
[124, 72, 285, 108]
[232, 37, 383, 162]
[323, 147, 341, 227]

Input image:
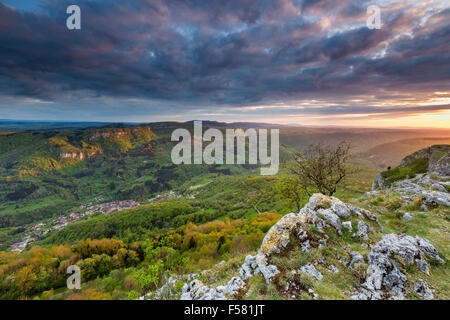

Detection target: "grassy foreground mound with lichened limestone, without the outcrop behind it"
[141, 194, 449, 300]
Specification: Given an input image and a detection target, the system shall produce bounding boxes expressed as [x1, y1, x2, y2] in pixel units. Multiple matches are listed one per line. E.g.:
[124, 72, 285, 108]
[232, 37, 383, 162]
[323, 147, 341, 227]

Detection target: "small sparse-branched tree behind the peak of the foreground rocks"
[289, 142, 352, 196]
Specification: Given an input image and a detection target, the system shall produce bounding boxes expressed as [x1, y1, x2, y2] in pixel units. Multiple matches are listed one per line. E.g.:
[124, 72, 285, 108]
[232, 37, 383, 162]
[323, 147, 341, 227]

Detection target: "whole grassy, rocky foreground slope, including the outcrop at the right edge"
[142, 145, 450, 300]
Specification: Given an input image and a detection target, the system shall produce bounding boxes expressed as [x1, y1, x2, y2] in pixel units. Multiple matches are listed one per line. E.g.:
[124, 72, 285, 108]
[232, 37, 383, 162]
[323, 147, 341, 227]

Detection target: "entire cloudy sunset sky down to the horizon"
[0, 0, 450, 128]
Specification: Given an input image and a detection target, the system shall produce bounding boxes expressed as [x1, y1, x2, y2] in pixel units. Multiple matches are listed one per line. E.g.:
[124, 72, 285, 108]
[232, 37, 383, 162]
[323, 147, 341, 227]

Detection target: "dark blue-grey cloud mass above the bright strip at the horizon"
[0, 0, 450, 120]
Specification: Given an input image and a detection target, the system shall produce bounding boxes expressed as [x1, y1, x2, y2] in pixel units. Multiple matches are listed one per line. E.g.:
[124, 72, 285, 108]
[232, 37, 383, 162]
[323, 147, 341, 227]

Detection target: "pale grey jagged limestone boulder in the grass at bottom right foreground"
[352, 234, 444, 300]
